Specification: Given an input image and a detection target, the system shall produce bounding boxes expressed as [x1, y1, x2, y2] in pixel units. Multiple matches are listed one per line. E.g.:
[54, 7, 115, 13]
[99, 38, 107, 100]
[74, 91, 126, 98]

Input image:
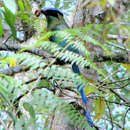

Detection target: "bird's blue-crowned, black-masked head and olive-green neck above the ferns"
[41, 8, 68, 31]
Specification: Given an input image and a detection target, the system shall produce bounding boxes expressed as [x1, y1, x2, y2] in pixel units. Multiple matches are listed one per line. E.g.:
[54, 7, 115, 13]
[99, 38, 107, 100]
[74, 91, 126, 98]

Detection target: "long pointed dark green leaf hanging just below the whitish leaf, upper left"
[3, 6, 16, 38]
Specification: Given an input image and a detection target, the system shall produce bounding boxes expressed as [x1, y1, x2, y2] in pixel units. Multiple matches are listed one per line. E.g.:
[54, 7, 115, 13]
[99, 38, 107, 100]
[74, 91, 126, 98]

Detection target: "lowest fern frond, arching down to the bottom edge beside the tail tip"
[31, 89, 93, 130]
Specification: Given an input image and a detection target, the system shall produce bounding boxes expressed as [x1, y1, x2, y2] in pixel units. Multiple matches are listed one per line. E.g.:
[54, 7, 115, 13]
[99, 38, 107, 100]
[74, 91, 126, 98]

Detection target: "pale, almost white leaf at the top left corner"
[3, 0, 17, 15]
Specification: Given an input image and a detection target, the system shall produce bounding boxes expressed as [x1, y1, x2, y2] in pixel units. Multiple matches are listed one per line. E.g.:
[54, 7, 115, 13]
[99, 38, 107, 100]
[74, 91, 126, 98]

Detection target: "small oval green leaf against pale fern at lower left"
[23, 102, 35, 119]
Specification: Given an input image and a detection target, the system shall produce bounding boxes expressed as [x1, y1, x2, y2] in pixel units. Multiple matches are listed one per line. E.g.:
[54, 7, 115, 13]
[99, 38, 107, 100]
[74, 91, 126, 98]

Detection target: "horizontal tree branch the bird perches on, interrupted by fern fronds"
[0, 43, 130, 64]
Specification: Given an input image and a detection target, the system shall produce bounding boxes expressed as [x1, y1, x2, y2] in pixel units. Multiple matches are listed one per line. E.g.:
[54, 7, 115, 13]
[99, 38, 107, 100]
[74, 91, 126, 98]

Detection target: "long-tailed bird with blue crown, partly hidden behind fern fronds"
[41, 8, 95, 127]
